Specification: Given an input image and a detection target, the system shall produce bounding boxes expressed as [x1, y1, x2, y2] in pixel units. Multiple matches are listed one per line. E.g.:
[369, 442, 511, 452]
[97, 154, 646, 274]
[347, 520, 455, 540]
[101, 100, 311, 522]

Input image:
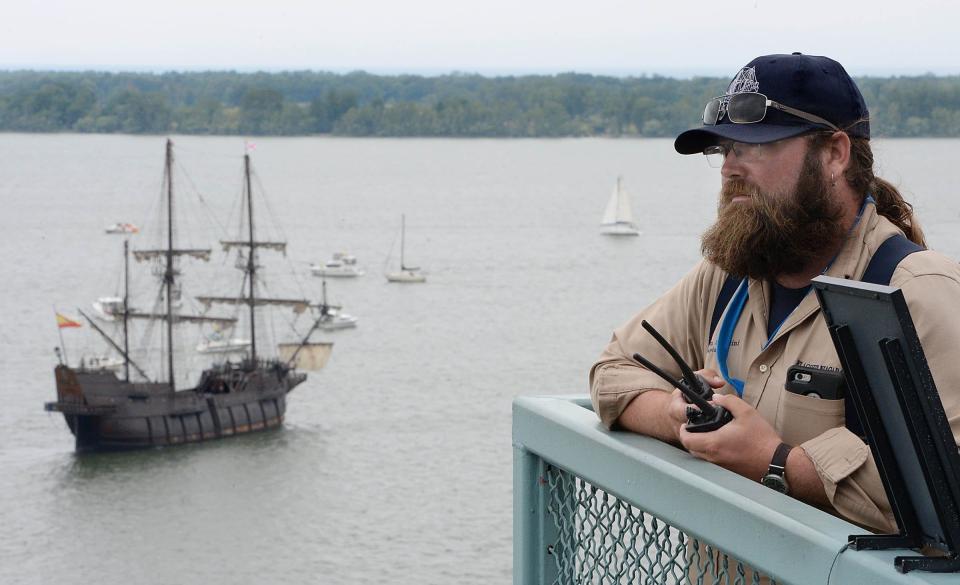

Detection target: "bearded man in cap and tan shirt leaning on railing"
[590, 53, 960, 532]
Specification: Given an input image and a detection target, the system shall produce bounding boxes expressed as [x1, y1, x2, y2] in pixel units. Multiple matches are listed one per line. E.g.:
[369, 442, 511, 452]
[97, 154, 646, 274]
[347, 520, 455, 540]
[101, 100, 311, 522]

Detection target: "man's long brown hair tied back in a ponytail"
[812, 132, 927, 247]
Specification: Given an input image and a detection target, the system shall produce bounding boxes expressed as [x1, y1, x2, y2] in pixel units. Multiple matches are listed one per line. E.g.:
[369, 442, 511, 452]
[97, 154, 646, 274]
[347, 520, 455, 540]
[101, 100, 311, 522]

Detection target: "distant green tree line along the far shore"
[0, 71, 960, 137]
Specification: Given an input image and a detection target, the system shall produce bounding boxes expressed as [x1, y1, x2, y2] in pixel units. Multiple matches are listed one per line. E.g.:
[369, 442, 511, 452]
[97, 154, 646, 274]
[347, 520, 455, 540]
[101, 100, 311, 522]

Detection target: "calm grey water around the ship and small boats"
[0, 134, 960, 585]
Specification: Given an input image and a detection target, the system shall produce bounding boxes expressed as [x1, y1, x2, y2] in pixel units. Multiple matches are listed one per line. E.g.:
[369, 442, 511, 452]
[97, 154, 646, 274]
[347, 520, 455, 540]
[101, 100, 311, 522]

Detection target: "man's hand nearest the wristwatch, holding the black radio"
[677, 390, 781, 481]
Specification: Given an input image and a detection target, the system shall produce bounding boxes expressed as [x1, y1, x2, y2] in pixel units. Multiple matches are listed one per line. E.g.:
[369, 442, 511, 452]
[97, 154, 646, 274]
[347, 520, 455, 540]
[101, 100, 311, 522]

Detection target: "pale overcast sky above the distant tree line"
[0, 0, 960, 77]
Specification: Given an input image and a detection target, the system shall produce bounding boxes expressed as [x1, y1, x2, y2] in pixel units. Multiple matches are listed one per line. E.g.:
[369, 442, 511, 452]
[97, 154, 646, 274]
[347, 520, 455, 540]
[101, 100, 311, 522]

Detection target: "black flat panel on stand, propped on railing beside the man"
[813, 276, 960, 573]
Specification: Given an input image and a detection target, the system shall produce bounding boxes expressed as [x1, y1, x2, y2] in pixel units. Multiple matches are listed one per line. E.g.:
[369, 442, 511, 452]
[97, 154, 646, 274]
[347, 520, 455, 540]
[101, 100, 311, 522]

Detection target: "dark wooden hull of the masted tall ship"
[46, 363, 306, 451]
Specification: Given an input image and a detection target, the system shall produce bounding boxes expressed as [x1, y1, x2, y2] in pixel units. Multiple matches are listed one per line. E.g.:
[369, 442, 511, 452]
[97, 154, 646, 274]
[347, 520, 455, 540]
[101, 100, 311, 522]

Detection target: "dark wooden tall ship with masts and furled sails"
[45, 140, 332, 451]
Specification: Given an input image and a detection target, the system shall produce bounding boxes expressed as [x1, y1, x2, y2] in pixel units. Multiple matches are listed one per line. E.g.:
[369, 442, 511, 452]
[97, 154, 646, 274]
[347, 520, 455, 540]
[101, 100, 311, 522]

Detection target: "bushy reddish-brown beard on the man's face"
[700, 150, 845, 279]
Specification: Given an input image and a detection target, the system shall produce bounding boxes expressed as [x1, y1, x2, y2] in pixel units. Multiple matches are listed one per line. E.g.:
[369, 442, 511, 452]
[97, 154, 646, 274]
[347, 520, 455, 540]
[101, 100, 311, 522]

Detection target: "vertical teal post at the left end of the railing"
[513, 445, 557, 585]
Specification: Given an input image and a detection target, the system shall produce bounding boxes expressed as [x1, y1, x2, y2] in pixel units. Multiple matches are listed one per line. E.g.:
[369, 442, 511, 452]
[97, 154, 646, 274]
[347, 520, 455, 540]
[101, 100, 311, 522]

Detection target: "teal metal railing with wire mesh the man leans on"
[513, 397, 948, 585]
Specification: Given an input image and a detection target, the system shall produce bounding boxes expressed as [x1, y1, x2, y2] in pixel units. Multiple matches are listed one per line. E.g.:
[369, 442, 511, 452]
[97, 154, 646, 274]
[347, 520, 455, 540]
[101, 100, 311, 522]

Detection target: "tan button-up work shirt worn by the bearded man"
[590, 204, 960, 532]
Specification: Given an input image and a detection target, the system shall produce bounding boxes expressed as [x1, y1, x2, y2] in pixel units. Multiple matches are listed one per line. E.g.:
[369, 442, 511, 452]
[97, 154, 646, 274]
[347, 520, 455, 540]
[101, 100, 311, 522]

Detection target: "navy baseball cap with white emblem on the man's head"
[673, 53, 870, 154]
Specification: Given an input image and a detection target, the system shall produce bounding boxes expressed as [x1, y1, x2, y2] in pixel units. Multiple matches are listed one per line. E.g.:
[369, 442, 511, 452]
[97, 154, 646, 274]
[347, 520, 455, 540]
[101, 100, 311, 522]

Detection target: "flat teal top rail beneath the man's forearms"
[513, 396, 956, 585]
